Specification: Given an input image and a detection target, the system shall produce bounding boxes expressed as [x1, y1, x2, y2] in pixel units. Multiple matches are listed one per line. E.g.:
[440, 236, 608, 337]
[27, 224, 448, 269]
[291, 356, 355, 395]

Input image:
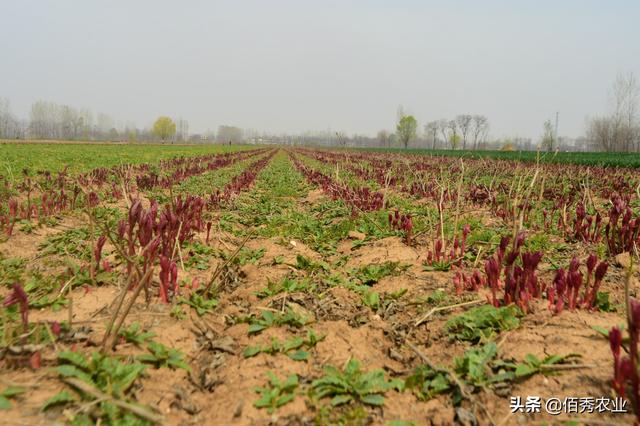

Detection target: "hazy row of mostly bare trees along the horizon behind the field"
[0, 73, 640, 152]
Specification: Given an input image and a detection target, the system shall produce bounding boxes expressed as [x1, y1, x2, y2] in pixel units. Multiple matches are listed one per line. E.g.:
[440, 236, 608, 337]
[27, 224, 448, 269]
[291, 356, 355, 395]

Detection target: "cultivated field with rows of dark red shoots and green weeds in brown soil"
[0, 144, 640, 426]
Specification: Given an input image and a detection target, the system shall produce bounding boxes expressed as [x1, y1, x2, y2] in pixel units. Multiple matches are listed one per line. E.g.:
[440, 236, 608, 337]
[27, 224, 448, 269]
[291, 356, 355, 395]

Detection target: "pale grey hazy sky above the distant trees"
[0, 0, 640, 139]
